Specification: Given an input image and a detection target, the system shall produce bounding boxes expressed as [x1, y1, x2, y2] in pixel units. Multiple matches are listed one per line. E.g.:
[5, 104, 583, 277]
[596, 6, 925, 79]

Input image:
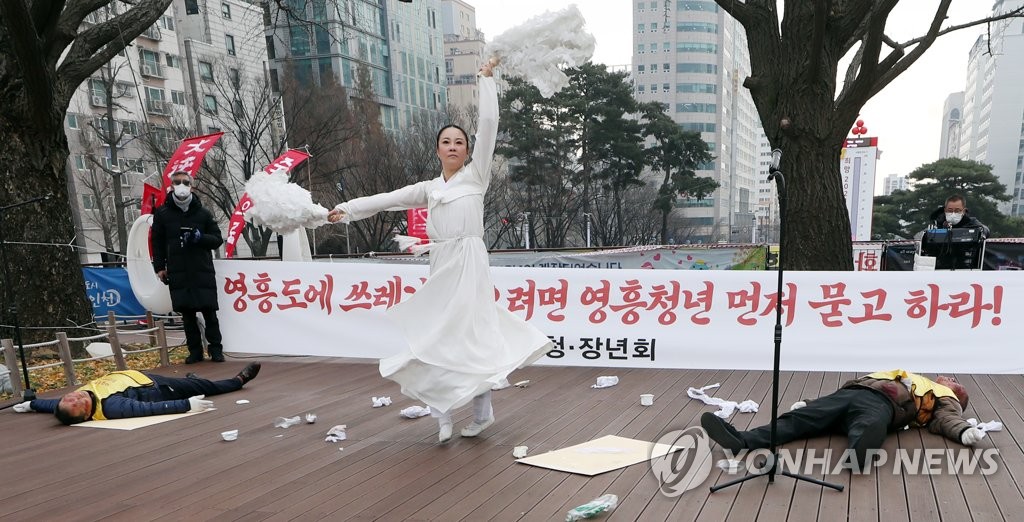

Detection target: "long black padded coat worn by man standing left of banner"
[153, 193, 224, 311]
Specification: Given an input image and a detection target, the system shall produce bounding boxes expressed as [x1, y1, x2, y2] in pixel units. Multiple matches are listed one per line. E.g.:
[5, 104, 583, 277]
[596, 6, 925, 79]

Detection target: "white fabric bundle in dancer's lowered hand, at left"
[245, 169, 328, 234]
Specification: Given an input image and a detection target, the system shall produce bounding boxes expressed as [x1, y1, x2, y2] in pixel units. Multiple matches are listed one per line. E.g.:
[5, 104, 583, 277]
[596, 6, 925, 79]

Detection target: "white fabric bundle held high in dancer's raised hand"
[484, 4, 595, 98]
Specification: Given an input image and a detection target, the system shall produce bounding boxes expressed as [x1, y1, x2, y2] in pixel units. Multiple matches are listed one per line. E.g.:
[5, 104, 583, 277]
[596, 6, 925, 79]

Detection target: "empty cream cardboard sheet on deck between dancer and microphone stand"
[516, 435, 685, 477]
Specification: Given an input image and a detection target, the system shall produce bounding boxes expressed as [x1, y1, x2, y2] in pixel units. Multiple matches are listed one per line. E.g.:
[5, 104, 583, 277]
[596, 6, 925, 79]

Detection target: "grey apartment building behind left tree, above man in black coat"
[66, 0, 280, 262]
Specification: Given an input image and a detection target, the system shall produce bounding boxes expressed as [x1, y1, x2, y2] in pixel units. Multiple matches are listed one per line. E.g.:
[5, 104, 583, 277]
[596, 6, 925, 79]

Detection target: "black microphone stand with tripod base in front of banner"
[711, 148, 843, 493]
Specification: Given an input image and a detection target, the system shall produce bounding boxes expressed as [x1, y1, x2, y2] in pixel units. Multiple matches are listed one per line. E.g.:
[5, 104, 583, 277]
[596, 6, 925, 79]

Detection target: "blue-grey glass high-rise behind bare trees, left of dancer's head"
[264, 0, 446, 130]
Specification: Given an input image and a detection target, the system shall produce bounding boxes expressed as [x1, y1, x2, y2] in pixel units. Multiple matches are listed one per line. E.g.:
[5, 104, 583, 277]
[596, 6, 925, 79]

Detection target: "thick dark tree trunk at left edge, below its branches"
[0, 122, 92, 343]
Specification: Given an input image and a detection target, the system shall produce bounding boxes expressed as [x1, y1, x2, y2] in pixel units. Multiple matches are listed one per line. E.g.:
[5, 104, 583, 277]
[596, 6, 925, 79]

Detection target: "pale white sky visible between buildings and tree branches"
[475, 0, 992, 192]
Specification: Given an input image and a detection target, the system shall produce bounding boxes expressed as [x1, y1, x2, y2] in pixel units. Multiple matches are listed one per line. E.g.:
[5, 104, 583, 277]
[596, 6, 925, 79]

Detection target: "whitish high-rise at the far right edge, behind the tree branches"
[957, 0, 1024, 216]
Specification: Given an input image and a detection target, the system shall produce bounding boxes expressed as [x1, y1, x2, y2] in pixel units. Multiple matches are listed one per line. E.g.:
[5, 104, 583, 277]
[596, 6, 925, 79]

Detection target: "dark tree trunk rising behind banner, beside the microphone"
[780, 138, 853, 270]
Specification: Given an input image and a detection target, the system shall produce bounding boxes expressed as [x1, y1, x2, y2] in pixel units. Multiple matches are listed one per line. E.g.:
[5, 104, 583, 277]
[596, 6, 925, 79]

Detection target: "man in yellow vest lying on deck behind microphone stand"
[700, 369, 984, 469]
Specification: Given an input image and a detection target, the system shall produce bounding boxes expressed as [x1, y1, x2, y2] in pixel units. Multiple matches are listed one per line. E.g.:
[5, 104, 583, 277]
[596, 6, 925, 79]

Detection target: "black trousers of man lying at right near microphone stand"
[740, 388, 893, 466]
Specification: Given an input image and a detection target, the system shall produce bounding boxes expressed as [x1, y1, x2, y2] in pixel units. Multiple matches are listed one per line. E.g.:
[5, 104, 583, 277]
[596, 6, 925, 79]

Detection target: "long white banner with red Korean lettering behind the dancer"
[215, 260, 1024, 374]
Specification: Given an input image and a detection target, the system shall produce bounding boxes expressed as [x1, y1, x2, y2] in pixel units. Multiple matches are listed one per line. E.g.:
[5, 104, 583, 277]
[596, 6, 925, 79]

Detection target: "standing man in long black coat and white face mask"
[153, 172, 224, 364]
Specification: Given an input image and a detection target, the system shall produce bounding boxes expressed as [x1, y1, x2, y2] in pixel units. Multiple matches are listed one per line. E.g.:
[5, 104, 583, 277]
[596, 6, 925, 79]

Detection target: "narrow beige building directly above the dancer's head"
[441, 0, 485, 107]
